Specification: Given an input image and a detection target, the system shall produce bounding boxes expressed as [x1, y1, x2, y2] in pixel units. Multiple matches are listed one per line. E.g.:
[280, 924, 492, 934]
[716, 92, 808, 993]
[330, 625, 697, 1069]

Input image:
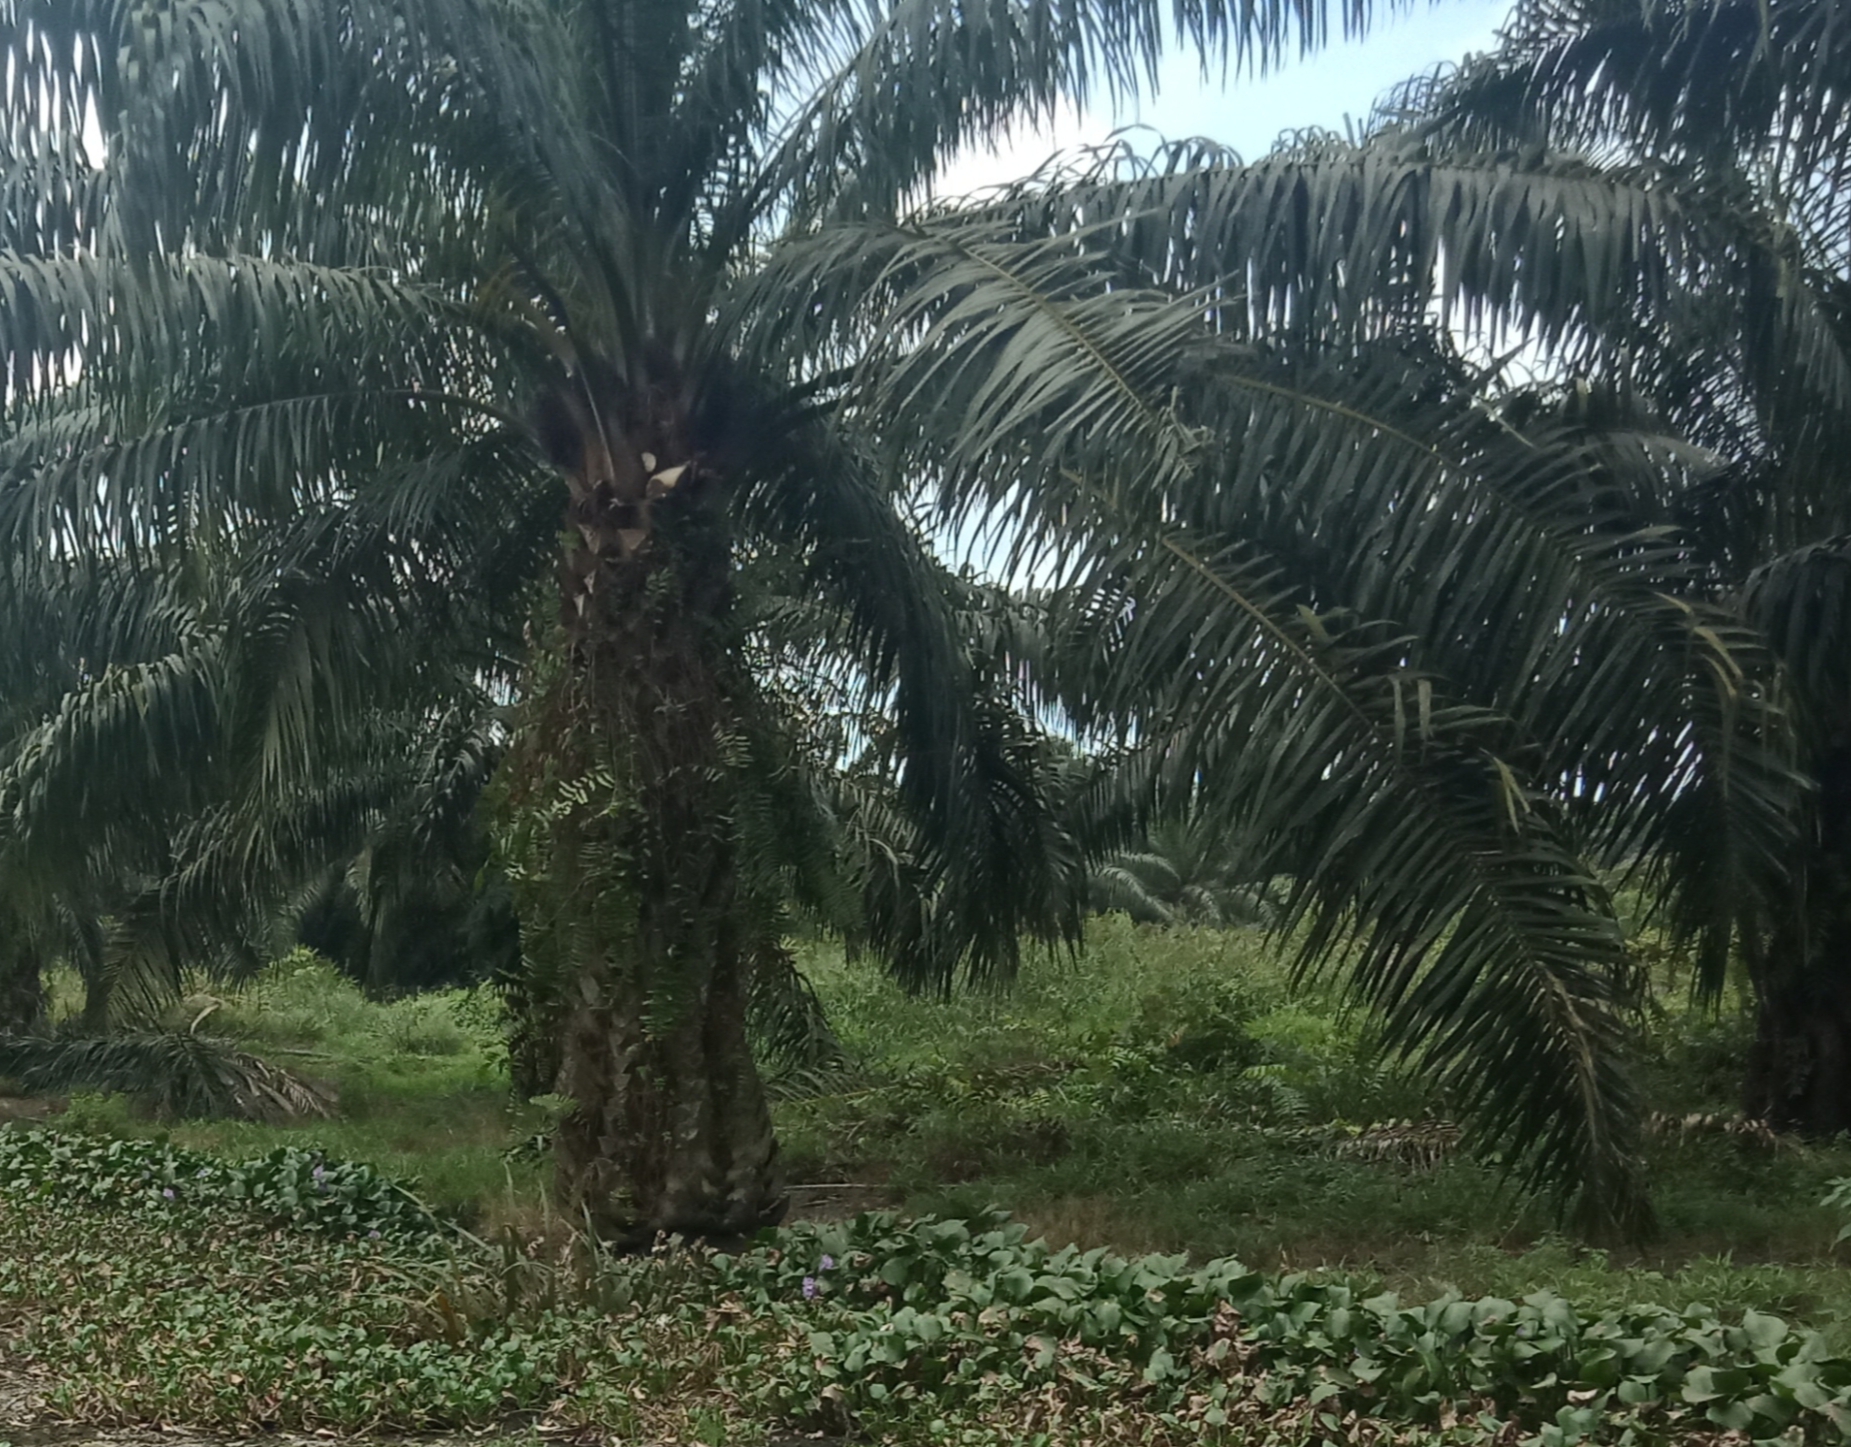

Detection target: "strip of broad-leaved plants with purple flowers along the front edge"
[0, 1132, 1851, 1447]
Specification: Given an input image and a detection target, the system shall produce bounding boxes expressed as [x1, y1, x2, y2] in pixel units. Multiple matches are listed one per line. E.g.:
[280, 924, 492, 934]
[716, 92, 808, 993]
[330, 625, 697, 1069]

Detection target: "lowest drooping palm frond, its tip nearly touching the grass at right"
[1066, 521, 1640, 1225]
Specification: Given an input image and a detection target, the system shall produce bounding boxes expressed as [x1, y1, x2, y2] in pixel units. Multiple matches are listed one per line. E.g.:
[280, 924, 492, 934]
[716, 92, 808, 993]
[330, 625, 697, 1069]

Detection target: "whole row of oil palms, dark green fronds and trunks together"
[0, 0, 1851, 1236]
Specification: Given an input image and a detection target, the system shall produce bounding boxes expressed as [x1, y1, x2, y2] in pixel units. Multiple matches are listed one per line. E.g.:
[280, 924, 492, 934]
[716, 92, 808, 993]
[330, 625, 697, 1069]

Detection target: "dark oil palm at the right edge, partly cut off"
[1377, 0, 1851, 1136]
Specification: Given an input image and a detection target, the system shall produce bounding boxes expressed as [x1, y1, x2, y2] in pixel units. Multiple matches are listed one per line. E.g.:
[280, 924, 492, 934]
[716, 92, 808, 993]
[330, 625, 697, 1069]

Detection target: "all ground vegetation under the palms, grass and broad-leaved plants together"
[0, 936, 1851, 1441]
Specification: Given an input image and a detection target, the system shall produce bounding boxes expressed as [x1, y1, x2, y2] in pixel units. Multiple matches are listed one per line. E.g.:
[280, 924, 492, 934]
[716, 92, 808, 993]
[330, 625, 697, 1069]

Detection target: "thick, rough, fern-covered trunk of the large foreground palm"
[510, 368, 785, 1243]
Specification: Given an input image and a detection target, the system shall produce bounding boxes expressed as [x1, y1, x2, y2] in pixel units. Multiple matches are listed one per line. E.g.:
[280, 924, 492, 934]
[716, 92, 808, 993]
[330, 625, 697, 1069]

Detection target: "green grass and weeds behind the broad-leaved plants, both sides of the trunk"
[21, 920, 1851, 1347]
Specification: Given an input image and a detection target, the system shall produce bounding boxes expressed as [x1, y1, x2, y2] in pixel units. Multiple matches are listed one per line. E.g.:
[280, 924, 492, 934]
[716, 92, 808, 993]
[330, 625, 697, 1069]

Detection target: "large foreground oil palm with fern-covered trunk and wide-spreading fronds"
[14, 0, 1795, 1238]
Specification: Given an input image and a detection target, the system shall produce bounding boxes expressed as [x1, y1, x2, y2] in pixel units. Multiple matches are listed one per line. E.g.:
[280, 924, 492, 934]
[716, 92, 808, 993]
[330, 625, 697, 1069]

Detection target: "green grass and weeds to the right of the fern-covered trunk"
[779, 918, 1851, 1351]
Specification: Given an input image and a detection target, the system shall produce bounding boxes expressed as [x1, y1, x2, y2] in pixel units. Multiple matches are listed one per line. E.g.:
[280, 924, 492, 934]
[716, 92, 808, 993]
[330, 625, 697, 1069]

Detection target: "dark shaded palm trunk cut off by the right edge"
[1744, 742, 1851, 1138]
